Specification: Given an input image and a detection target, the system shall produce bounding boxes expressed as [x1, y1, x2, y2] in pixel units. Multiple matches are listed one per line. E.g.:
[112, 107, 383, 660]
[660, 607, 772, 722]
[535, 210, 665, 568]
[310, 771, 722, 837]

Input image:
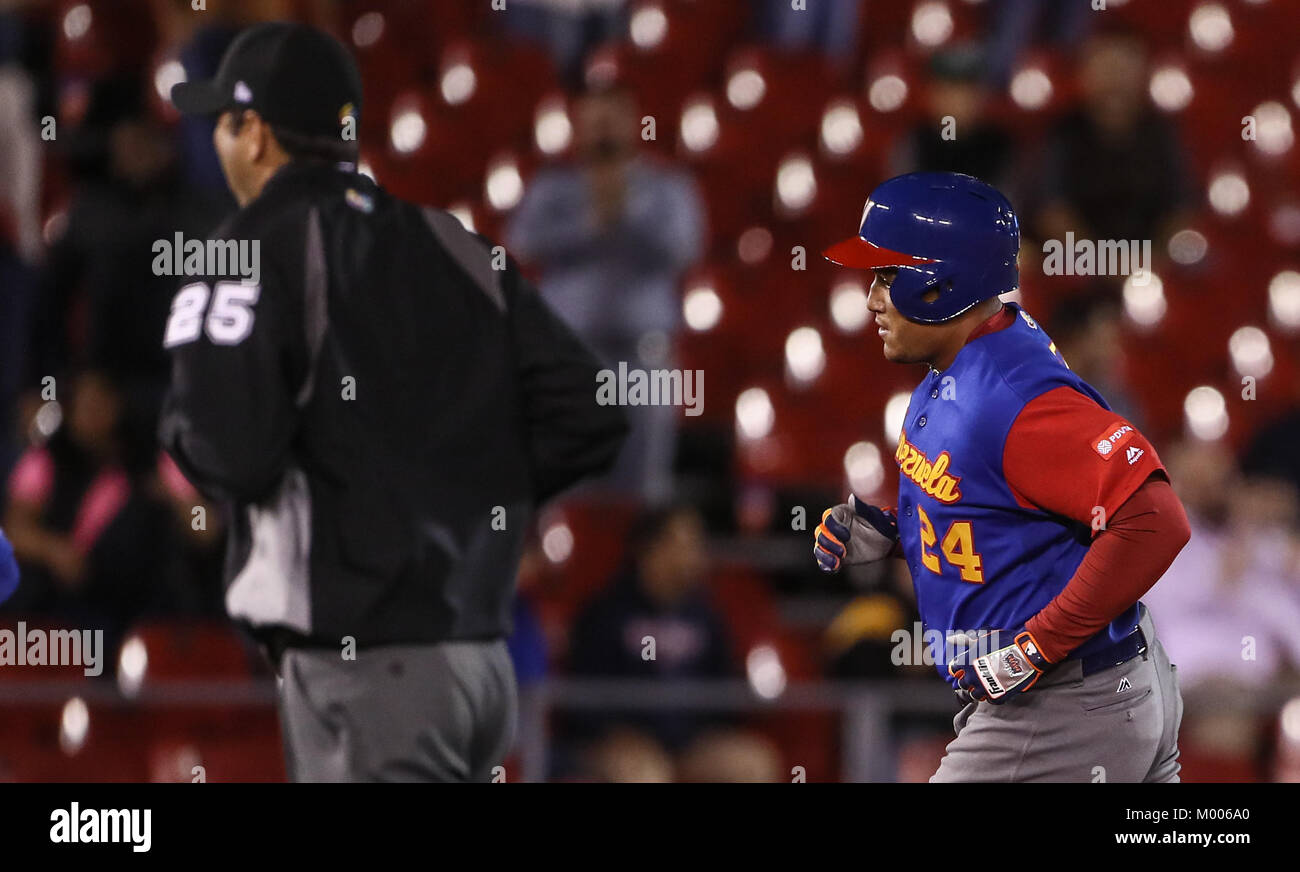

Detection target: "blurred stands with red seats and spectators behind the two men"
[0, 0, 1300, 781]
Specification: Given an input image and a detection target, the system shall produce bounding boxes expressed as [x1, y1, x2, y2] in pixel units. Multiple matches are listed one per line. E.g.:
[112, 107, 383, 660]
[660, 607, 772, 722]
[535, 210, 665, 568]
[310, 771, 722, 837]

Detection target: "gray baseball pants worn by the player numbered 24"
[930, 606, 1183, 781]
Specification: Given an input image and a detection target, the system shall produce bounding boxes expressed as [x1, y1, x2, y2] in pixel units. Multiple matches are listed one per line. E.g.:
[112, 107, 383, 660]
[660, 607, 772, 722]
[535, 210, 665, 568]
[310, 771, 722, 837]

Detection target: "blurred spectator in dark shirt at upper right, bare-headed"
[1036, 31, 1191, 251]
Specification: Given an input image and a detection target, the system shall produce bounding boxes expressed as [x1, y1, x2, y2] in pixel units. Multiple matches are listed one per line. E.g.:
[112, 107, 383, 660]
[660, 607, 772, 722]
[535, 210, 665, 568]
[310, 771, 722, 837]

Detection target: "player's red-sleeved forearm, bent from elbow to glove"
[1026, 478, 1191, 661]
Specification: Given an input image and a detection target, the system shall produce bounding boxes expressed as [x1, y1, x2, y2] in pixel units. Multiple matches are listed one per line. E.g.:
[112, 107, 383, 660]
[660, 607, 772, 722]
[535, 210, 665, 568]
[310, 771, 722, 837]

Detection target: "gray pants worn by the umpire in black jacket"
[280, 641, 517, 782]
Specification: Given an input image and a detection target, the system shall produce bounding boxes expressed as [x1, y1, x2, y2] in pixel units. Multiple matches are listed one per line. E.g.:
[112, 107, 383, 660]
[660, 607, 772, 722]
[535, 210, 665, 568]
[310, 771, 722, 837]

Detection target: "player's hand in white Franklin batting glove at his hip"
[948, 624, 1052, 704]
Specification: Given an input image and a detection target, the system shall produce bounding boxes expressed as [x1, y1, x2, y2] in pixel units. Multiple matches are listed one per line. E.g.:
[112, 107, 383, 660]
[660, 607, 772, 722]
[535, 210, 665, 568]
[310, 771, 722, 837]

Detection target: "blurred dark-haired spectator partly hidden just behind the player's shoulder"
[1049, 290, 1143, 430]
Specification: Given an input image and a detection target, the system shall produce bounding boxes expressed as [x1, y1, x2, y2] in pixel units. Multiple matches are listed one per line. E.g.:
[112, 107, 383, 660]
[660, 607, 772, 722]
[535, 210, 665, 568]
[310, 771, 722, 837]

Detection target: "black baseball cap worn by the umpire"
[172, 21, 361, 136]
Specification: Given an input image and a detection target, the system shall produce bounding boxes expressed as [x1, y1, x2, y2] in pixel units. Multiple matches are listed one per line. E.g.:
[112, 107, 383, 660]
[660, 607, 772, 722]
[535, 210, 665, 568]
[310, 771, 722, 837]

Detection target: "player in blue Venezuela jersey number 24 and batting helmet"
[814, 173, 1190, 781]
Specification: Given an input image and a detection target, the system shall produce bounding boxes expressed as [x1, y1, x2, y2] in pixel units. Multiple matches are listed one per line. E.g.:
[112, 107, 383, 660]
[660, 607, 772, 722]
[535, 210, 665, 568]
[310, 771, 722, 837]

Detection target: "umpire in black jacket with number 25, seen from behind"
[161, 23, 625, 781]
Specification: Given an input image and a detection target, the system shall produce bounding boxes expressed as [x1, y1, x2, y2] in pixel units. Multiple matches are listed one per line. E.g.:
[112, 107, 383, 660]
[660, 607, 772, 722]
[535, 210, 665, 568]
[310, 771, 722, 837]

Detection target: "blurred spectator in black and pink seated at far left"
[4, 372, 220, 657]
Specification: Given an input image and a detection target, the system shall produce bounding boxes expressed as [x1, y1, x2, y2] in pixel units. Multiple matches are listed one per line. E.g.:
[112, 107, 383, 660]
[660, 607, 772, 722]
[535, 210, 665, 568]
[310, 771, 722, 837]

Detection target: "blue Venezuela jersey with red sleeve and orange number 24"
[896, 303, 1164, 678]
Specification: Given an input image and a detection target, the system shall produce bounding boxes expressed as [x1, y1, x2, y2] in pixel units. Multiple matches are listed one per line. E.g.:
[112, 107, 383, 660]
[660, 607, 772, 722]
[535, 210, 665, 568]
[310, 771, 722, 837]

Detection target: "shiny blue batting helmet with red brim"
[822, 173, 1021, 324]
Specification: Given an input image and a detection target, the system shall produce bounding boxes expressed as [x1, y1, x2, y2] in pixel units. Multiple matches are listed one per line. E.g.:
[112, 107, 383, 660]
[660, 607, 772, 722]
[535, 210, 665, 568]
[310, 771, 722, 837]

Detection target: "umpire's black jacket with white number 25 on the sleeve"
[161, 164, 627, 647]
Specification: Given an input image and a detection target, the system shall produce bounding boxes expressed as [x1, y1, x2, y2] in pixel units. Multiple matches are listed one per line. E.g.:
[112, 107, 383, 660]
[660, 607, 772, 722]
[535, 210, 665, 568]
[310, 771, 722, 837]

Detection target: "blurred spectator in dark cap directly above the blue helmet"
[893, 45, 1013, 187]
